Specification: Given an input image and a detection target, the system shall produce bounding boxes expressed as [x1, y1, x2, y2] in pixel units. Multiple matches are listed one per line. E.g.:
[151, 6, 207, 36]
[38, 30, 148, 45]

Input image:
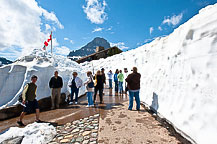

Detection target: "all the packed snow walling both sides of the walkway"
[0, 4, 217, 144]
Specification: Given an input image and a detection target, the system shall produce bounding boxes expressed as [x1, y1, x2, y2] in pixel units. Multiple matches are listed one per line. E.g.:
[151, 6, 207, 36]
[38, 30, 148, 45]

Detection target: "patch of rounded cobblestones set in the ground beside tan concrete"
[49, 114, 99, 144]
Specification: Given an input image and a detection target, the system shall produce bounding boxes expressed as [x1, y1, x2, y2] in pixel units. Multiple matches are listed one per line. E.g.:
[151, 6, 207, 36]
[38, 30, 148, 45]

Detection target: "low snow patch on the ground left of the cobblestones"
[0, 123, 56, 144]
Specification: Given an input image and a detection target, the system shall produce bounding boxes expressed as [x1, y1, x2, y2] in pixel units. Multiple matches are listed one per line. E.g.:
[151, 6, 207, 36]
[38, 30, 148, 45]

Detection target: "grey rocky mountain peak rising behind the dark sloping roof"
[68, 37, 111, 58]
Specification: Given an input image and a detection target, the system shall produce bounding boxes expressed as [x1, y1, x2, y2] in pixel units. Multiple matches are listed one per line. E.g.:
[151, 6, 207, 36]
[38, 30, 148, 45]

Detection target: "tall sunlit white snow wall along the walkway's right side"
[83, 4, 217, 144]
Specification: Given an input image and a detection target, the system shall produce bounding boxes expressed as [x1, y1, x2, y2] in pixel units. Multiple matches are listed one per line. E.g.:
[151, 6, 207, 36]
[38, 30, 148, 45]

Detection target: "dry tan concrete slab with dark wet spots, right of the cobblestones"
[98, 102, 180, 144]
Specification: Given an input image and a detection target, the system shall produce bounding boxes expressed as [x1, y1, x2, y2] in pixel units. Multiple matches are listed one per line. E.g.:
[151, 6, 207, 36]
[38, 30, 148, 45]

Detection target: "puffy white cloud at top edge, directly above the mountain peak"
[83, 0, 107, 24]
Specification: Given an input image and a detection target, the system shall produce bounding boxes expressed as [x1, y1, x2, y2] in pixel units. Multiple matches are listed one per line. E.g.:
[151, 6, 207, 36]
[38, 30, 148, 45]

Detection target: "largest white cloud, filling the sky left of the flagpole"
[0, 0, 64, 57]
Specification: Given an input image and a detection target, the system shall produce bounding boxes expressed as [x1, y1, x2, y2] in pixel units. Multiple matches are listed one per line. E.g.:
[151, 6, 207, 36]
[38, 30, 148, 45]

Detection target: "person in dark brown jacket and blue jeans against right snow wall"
[126, 67, 141, 111]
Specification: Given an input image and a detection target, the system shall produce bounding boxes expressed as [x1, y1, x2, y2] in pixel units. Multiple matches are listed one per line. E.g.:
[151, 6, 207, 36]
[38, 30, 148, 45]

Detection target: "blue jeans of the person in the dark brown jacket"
[128, 90, 140, 110]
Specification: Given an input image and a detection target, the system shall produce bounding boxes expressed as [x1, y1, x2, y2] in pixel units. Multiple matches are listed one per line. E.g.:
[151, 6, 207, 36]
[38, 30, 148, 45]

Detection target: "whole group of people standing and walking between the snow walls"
[17, 67, 141, 126]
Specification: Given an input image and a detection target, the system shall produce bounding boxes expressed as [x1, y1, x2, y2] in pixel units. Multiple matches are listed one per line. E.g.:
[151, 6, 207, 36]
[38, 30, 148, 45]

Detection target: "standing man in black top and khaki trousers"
[49, 71, 63, 109]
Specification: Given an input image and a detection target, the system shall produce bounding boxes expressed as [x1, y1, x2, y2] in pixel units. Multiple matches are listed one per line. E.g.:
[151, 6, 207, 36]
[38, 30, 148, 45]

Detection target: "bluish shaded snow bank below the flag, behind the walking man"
[0, 50, 86, 109]
